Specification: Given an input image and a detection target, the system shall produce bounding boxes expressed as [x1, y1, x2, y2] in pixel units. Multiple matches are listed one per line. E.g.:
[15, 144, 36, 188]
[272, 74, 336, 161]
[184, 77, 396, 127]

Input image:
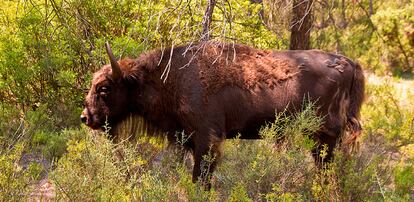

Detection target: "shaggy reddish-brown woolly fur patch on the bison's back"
[197, 44, 299, 94]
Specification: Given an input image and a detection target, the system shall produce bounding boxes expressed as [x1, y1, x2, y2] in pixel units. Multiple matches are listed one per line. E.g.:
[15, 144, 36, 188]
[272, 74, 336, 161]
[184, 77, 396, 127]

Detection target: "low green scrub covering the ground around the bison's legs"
[0, 79, 414, 201]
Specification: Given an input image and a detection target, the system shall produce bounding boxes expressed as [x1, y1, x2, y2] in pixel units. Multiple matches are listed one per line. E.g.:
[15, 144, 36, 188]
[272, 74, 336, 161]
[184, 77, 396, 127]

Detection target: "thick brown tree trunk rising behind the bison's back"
[290, 0, 313, 50]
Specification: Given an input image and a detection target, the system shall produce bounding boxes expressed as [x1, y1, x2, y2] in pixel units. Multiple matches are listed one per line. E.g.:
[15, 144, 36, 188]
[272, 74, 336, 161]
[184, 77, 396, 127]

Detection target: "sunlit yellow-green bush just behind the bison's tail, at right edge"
[363, 79, 414, 148]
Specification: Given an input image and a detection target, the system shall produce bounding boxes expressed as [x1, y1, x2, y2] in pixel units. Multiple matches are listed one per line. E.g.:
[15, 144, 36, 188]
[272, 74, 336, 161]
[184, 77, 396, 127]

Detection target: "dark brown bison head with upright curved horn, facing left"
[80, 43, 130, 129]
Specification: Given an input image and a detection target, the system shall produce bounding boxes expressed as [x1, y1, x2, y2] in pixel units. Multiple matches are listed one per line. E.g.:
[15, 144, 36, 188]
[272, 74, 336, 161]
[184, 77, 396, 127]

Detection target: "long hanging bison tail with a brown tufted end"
[345, 63, 365, 147]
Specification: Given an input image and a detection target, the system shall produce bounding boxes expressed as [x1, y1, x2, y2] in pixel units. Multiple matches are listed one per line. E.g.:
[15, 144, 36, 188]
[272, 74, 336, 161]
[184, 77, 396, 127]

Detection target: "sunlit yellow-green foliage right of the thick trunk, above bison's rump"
[312, 0, 414, 76]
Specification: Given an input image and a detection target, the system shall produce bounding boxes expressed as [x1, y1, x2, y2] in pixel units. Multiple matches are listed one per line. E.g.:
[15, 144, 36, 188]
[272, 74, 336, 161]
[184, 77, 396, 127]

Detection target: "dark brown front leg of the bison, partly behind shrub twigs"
[193, 131, 224, 189]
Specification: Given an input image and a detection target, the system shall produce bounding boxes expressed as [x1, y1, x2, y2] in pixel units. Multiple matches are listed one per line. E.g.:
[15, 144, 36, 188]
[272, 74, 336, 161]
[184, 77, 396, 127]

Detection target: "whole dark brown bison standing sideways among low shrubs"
[81, 42, 364, 189]
